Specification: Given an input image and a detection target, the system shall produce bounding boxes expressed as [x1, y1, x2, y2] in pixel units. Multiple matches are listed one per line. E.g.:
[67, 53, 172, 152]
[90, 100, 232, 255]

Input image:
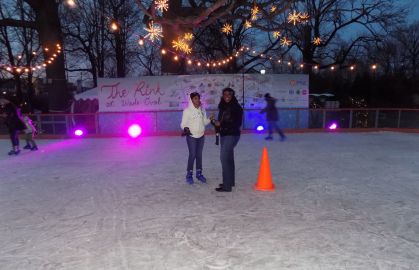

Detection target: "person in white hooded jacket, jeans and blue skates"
[180, 92, 211, 184]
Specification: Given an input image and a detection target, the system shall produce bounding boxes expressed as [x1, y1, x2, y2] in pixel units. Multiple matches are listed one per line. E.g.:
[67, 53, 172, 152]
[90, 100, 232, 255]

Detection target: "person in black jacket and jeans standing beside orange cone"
[211, 88, 243, 192]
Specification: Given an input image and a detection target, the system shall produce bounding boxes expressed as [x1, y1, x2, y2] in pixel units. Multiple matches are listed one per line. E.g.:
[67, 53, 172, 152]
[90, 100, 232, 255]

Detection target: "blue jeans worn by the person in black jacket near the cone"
[220, 136, 240, 190]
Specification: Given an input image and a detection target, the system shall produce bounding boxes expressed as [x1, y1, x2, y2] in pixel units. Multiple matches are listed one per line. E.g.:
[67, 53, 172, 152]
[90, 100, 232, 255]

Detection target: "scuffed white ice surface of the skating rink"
[0, 132, 419, 270]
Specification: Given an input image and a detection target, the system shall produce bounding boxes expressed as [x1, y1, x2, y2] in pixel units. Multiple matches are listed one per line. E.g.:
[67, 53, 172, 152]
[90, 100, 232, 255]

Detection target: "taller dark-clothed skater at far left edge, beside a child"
[0, 99, 26, 156]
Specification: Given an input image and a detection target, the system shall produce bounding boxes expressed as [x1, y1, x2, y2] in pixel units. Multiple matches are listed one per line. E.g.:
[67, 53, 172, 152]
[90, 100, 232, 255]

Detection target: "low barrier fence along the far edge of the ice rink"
[0, 108, 419, 136]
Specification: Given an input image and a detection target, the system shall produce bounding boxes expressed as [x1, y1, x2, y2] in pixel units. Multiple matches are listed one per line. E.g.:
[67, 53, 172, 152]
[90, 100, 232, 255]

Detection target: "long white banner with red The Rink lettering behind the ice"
[98, 74, 309, 112]
